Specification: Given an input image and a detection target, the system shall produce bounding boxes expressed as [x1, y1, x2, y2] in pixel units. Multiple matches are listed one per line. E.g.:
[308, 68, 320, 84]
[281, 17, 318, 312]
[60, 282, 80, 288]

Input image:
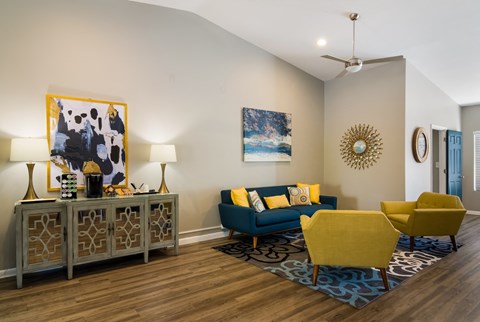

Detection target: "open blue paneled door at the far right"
[447, 130, 463, 199]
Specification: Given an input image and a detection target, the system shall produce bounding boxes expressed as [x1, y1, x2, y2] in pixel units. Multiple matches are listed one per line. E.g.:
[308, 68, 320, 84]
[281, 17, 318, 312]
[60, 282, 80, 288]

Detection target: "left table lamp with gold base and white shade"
[10, 138, 50, 200]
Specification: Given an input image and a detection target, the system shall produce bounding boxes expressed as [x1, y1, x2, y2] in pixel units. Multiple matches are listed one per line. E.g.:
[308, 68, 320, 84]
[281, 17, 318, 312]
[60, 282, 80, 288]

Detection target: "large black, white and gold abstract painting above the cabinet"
[46, 94, 128, 191]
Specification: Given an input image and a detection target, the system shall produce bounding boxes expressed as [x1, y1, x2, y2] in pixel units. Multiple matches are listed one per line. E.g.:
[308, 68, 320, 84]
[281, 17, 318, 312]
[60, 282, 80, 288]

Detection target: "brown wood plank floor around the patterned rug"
[0, 215, 480, 321]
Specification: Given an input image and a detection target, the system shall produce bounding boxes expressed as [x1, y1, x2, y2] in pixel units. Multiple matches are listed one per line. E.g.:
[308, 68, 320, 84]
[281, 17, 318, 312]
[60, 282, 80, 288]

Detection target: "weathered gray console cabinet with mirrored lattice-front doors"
[15, 194, 178, 288]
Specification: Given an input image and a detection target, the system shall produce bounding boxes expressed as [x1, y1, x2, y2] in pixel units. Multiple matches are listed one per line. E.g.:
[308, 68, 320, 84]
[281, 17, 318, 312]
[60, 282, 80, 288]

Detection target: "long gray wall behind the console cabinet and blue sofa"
[0, 0, 326, 271]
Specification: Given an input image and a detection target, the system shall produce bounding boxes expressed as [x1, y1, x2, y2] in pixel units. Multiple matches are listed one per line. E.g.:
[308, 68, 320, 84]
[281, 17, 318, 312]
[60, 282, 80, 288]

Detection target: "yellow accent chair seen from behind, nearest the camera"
[300, 210, 400, 291]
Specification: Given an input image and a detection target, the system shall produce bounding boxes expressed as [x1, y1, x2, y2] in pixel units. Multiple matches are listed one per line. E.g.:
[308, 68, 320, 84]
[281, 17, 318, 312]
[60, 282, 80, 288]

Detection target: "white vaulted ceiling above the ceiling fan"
[131, 0, 480, 105]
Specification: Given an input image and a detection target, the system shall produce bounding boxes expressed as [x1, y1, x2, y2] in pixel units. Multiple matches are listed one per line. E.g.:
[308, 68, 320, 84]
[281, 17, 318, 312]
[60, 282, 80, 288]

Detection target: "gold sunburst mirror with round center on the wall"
[340, 124, 383, 170]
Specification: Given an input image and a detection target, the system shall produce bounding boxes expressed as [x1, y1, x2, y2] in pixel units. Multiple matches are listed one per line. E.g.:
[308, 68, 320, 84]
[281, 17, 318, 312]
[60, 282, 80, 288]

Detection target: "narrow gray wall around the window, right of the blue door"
[461, 105, 480, 213]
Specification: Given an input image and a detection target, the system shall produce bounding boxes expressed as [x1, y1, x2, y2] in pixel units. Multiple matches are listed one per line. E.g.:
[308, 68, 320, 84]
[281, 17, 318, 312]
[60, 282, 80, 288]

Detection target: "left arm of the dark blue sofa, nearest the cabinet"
[218, 203, 256, 233]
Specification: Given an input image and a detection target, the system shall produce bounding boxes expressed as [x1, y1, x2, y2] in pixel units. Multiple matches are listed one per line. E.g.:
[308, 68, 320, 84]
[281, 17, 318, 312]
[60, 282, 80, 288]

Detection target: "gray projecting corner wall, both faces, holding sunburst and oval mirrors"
[324, 61, 460, 209]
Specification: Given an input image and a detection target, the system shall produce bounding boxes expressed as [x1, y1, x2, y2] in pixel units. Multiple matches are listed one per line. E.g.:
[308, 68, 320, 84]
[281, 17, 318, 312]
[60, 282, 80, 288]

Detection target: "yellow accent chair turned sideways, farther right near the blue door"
[380, 192, 467, 252]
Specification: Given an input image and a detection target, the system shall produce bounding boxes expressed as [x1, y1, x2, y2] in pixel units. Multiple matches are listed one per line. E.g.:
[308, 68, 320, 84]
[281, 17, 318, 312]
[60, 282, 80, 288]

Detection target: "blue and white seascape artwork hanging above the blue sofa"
[243, 107, 292, 162]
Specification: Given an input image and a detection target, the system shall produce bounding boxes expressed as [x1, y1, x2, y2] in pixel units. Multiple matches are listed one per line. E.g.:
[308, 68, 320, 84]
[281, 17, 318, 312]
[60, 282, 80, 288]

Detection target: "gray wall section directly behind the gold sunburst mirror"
[324, 61, 405, 210]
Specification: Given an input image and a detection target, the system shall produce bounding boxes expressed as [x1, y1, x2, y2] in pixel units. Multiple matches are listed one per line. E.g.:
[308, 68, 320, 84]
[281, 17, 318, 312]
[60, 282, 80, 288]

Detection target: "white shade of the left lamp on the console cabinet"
[10, 138, 50, 162]
